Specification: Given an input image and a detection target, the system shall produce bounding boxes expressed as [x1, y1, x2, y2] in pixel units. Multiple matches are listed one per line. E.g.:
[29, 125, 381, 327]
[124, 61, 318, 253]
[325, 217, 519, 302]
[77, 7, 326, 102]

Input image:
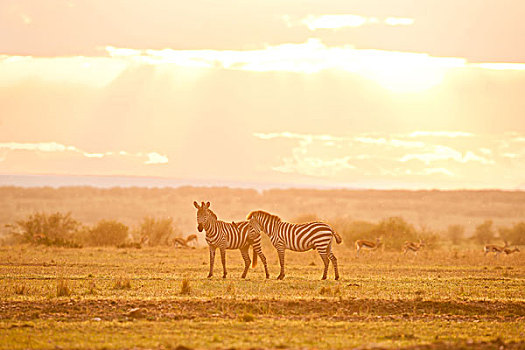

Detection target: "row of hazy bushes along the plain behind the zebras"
[4, 212, 525, 250]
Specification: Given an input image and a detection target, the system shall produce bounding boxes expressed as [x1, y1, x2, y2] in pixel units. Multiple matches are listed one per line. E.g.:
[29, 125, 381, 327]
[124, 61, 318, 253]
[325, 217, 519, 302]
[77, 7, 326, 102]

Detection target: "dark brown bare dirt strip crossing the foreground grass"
[0, 298, 525, 321]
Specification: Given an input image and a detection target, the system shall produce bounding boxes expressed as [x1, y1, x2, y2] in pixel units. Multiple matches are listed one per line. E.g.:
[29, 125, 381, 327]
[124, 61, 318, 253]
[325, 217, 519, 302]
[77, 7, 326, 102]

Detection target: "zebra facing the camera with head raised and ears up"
[193, 202, 270, 278]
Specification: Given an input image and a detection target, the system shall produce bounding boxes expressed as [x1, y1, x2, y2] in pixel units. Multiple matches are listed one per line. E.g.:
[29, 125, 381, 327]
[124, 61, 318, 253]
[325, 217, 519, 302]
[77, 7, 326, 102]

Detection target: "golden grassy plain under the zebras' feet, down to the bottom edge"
[0, 245, 525, 349]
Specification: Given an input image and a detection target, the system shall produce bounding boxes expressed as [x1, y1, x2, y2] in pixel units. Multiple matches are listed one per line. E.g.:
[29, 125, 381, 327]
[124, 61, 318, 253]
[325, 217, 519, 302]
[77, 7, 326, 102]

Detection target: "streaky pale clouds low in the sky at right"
[254, 131, 525, 183]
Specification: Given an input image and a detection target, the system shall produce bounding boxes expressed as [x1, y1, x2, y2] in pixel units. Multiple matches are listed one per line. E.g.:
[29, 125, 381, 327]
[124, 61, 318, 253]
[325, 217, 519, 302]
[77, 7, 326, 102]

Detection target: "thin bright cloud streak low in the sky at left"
[0, 142, 168, 164]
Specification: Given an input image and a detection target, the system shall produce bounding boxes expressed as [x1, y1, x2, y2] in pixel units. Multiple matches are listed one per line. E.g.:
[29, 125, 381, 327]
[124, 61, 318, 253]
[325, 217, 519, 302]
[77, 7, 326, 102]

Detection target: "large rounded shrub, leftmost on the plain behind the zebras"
[12, 212, 81, 248]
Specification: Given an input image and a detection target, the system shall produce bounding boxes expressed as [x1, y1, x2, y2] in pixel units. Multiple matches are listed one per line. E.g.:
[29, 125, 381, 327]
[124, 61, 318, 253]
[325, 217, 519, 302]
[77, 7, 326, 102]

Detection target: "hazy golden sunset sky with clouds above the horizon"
[0, 0, 525, 189]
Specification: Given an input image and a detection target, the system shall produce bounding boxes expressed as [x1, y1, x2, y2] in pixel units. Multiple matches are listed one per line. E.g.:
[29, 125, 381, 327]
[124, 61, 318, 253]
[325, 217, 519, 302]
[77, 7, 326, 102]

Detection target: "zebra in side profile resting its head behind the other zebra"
[248, 210, 342, 280]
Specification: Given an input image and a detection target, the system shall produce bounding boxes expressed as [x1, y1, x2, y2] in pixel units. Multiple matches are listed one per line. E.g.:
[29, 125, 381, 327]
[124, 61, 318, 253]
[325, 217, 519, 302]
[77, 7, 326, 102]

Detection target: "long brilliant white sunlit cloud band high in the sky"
[107, 39, 466, 93]
